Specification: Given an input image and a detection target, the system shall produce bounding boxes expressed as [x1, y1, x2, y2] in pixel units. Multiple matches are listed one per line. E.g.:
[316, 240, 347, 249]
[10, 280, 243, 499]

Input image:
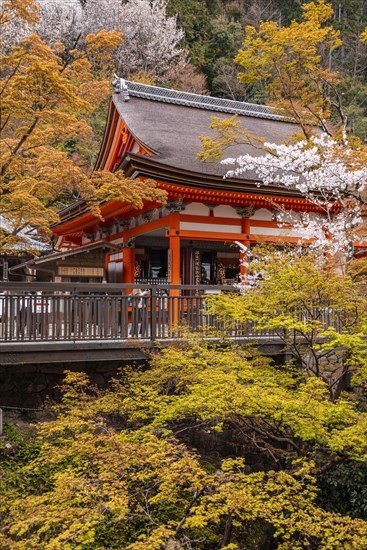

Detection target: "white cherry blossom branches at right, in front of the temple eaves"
[222, 134, 367, 257]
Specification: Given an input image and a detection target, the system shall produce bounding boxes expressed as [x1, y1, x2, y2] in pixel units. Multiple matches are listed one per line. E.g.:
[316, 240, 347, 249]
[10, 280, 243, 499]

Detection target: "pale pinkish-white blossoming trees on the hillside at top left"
[3, 0, 187, 77]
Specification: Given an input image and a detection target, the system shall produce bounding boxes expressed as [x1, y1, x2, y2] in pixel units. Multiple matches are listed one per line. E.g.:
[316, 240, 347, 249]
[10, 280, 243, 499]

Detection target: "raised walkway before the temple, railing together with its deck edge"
[0, 283, 344, 364]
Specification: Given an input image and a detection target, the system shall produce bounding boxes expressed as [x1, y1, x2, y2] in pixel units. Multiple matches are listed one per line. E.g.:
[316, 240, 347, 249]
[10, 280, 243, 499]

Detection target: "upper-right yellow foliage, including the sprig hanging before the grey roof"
[198, 0, 350, 161]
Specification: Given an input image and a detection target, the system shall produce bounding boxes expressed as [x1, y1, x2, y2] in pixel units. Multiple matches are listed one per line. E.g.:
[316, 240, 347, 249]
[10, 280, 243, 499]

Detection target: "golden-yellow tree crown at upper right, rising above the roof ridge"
[235, 0, 341, 137]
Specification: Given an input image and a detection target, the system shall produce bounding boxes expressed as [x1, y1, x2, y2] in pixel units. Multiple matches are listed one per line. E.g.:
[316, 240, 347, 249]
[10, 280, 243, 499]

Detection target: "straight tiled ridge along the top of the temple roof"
[124, 80, 289, 121]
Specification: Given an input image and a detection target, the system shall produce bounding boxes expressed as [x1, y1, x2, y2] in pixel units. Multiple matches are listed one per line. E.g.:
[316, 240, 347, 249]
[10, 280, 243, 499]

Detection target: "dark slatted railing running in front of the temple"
[0, 283, 339, 343]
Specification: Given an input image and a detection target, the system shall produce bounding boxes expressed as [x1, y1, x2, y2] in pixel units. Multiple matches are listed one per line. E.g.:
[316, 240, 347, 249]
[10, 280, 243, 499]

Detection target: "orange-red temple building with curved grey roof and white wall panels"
[18, 79, 326, 284]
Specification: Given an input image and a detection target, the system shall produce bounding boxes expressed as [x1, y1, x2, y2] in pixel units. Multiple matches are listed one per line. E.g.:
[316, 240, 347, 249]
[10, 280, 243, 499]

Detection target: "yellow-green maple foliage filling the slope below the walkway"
[0, 362, 367, 550]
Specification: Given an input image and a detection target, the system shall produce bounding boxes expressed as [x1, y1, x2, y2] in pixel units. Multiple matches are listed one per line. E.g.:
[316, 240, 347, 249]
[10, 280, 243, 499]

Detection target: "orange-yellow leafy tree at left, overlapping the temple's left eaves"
[0, 22, 165, 252]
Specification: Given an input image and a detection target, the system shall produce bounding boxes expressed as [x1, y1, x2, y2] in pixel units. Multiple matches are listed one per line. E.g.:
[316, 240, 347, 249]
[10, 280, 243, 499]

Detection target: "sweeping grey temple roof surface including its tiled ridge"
[113, 81, 299, 181]
